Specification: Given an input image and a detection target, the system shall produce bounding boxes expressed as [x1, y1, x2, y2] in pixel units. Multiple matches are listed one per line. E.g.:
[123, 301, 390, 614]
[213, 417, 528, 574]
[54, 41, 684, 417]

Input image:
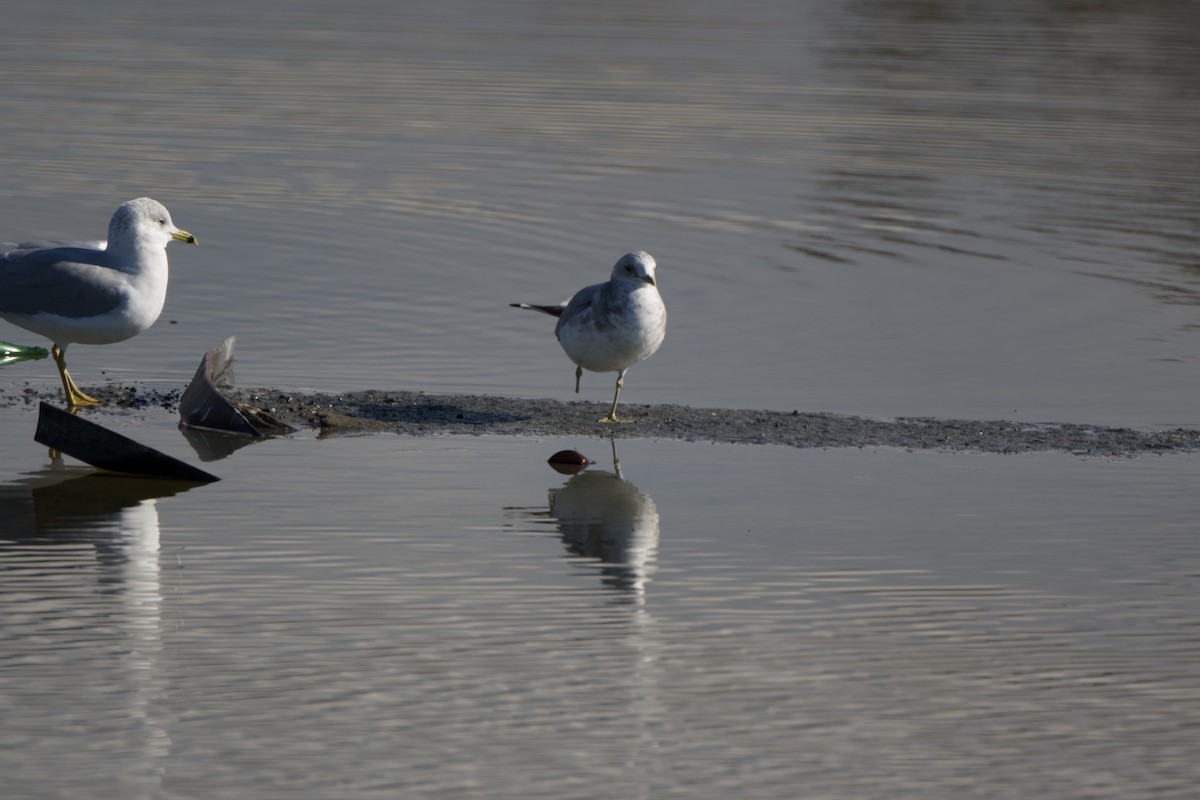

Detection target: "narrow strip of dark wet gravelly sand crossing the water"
[0, 384, 1200, 456]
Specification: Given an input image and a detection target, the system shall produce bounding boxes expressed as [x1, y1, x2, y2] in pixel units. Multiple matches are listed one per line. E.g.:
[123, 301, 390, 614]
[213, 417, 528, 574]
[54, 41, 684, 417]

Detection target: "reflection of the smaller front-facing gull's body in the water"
[550, 467, 659, 591]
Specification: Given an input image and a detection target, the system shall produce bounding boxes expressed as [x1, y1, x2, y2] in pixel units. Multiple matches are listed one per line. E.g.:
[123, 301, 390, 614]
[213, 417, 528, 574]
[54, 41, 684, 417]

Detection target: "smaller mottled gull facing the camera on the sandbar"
[510, 251, 667, 422]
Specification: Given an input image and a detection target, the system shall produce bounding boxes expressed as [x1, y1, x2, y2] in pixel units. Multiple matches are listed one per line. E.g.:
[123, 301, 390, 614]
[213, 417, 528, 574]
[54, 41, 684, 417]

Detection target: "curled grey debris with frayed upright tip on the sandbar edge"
[179, 336, 295, 450]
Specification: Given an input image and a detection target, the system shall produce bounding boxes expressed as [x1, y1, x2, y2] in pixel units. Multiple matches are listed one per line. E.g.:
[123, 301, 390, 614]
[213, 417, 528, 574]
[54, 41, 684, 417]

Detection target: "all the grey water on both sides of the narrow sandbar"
[0, 0, 1200, 798]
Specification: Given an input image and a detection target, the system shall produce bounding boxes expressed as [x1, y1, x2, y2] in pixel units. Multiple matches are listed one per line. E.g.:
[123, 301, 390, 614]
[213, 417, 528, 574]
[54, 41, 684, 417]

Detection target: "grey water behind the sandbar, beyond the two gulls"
[0, 0, 1200, 426]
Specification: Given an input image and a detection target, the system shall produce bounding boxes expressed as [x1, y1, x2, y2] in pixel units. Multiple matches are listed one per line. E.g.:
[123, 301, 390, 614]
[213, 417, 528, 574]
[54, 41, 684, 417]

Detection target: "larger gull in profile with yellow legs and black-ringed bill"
[0, 197, 197, 408]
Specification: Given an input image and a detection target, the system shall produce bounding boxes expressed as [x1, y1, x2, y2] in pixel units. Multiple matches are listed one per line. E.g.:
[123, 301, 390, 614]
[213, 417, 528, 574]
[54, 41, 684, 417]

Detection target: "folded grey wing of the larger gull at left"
[0, 247, 127, 317]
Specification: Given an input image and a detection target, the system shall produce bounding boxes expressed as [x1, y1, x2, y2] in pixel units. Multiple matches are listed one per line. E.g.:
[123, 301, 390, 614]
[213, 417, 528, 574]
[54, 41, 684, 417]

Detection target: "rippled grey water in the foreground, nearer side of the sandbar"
[0, 414, 1200, 798]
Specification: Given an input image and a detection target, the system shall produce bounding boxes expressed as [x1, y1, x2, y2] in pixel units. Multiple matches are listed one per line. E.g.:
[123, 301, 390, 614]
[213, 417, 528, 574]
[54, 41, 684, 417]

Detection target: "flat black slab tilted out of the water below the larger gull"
[34, 402, 221, 483]
